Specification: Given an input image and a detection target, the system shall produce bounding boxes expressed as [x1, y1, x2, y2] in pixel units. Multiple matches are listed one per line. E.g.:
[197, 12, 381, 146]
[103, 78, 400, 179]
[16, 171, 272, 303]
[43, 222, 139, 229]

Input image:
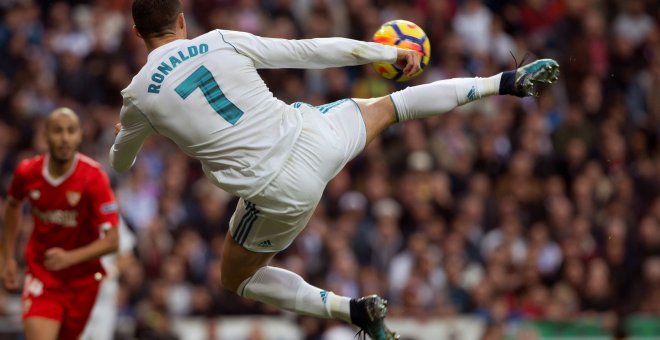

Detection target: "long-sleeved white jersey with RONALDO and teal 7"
[110, 30, 397, 199]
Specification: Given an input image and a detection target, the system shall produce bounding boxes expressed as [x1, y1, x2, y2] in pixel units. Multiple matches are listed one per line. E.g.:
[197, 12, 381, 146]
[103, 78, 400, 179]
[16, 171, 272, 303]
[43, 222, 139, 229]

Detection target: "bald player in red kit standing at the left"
[2, 108, 118, 340]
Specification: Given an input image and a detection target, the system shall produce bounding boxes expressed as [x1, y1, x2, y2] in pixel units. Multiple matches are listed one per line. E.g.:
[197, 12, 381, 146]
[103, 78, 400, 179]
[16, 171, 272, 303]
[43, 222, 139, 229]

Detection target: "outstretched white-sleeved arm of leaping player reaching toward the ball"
[217, 30, 402, 68]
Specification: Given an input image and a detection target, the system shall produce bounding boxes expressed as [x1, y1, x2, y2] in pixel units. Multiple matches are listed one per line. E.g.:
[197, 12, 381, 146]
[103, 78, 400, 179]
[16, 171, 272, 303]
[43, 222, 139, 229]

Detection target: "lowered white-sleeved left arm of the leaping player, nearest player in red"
[110, 98, 155, 172]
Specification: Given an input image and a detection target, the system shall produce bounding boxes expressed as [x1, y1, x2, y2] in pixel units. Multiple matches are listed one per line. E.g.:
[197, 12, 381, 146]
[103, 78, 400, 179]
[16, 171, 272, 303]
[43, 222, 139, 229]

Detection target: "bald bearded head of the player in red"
[46, 115, 82, 162]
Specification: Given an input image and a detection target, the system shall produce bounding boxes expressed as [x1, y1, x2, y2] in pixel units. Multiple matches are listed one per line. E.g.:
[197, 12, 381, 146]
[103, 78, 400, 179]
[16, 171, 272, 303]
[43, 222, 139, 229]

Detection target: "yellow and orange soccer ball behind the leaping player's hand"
[373, 20, 431, 82]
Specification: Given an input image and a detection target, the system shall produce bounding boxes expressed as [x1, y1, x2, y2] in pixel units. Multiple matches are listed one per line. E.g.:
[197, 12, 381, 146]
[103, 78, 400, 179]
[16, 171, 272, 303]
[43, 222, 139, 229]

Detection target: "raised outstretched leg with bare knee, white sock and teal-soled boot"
[355, 59, 559, 142]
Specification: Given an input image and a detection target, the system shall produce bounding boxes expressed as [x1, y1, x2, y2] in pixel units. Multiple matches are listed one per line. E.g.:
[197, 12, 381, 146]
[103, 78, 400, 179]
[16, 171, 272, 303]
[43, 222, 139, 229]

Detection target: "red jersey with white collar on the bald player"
[8, 153, 119, 287]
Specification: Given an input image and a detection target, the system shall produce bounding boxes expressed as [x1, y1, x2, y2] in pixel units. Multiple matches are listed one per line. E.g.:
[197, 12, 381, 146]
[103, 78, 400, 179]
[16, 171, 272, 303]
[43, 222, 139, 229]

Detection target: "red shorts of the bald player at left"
[22, 274, 100, 340]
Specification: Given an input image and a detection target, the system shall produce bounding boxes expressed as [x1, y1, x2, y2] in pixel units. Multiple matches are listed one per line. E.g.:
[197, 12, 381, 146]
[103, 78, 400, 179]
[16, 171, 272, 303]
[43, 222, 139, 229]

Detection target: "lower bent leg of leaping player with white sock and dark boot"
[221, 236, 398, 340]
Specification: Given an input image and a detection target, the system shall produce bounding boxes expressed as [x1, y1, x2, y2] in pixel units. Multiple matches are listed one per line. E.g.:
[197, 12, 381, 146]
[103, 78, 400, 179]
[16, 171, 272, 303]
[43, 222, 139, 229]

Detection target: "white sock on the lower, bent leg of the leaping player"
[238, 267, 351, 323]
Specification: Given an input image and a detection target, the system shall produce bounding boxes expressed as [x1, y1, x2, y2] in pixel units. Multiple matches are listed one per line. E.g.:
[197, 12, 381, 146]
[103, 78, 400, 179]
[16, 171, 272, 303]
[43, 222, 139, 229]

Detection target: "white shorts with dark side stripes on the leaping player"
[229, 99, 367, 253]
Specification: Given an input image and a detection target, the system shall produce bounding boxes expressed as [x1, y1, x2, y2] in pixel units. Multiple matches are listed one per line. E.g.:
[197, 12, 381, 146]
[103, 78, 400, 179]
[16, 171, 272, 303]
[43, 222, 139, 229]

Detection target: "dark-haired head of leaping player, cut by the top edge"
[132, 0, 183, 39]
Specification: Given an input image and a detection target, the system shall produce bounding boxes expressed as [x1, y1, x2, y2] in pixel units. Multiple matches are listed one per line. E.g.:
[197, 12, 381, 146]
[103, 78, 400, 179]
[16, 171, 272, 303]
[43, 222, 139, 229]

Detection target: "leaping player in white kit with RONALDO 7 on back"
[110, 0, 559, 340]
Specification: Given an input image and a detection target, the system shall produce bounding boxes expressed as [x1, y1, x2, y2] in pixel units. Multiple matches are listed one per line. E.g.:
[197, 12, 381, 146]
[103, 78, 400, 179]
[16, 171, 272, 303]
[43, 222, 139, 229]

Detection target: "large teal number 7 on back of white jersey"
[174, 66, 243, 125]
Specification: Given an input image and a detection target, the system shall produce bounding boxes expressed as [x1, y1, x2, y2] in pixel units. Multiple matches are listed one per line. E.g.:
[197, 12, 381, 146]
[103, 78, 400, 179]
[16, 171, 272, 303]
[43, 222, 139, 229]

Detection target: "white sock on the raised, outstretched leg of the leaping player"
[390, 73, 502, 122]
